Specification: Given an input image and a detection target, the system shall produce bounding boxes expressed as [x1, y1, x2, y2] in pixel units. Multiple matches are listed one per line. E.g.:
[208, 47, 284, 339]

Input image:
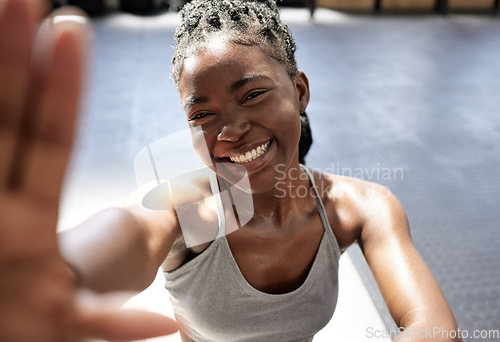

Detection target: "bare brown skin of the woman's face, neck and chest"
[176, 39, 323, 293]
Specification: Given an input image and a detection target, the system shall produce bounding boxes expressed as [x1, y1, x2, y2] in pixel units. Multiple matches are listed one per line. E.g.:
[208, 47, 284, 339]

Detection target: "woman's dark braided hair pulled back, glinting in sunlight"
[172, 0, 312, 163]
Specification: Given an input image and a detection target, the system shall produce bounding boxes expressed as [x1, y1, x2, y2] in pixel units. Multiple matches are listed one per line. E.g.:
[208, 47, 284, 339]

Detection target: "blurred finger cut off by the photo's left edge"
[0, 0, 41, 186]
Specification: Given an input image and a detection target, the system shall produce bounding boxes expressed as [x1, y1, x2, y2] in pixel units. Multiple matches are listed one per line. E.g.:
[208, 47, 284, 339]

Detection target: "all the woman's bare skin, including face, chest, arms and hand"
[0, 0, 456, 342]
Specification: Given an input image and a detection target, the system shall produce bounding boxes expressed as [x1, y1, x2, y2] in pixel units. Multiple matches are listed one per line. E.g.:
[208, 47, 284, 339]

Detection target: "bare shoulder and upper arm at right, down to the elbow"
[306, 168, 457, 331]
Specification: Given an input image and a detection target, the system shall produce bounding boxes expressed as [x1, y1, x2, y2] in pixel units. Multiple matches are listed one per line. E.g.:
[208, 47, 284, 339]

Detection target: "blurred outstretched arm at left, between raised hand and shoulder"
[59, 182, 178, 292]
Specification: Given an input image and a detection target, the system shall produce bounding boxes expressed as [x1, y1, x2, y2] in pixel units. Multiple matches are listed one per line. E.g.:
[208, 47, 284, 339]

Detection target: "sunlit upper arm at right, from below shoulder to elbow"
[358, 185, 456, 329]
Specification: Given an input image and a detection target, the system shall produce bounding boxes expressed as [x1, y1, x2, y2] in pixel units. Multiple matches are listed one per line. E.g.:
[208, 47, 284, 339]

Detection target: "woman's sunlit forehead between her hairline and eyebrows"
[179, 38, 288, 99]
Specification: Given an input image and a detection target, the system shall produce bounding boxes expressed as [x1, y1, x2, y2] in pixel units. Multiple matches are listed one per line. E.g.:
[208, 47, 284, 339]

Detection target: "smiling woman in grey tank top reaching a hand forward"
[0, 0, 457, 341]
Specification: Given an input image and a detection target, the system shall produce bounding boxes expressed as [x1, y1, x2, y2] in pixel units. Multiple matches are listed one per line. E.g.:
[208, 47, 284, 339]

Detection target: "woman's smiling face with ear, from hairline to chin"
[179, 38, 309, 193]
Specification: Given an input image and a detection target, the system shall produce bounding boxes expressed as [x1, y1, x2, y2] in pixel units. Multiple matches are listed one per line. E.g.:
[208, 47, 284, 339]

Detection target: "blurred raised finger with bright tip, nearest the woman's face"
[16, 10, 88, 205]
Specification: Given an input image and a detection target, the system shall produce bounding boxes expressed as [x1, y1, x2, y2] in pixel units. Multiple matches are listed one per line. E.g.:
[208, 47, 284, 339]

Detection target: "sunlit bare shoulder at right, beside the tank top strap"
[306, 170, 408, 248]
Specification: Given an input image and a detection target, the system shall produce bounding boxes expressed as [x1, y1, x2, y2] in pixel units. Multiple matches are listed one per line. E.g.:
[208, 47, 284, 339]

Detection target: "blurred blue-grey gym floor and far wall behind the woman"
[56, 0, 500, 342]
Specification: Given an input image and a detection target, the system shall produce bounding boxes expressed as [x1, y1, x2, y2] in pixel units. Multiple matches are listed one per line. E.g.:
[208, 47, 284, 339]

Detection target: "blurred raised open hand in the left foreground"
[0, 0, 177, 342]
